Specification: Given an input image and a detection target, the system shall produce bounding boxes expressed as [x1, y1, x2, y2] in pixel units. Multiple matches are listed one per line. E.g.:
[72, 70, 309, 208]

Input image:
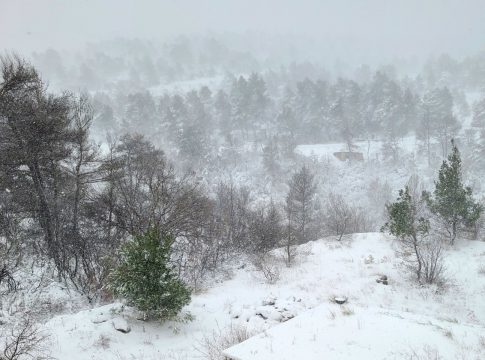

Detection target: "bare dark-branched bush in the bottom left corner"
[0, 318, 50, 360]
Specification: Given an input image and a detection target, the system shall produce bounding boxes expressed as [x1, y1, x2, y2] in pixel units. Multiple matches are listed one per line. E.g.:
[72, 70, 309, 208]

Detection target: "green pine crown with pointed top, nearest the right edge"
[424, 140, 483, 244]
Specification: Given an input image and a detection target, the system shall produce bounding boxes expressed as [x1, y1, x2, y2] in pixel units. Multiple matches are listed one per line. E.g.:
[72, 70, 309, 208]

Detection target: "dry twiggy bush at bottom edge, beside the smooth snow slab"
[196, 324, 253, 360]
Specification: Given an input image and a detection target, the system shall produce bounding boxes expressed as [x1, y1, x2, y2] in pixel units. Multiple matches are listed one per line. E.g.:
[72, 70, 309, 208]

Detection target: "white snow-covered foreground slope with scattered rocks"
[40, 233, 485, 360]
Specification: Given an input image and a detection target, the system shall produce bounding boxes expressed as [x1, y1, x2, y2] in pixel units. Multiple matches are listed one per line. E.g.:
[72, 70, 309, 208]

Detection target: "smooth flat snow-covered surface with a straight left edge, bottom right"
[224, 304, 485, 360]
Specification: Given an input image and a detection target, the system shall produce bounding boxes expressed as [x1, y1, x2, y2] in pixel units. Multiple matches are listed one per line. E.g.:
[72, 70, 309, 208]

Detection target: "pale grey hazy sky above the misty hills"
[0, 0, 485, 61]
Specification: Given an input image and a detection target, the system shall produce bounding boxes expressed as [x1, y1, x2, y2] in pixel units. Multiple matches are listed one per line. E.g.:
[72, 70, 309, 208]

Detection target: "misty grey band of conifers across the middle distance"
[87, 67, 478, 171]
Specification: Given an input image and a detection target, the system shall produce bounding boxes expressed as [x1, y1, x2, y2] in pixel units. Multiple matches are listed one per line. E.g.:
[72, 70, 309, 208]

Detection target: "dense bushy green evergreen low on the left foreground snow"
[110, 228, 190, 319]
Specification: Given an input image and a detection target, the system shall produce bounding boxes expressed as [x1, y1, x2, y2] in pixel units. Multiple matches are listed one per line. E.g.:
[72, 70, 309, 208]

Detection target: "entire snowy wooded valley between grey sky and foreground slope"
[0, 35, 485, 324]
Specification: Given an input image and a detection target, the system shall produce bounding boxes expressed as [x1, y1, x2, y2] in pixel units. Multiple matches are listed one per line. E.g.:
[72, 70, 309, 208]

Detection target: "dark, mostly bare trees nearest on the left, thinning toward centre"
[0, 56, 365, 310]
